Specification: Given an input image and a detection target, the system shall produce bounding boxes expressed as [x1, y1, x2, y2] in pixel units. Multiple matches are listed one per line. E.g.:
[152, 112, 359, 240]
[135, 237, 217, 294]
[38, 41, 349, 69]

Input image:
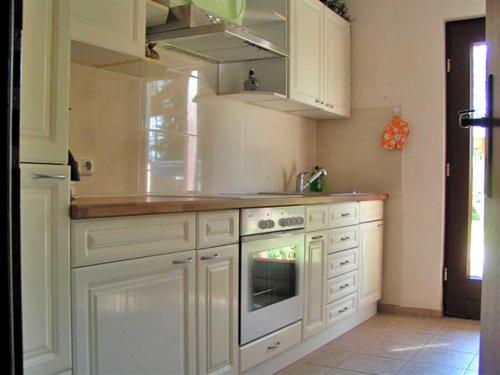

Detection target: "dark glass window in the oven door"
[249, 245, 298, 311]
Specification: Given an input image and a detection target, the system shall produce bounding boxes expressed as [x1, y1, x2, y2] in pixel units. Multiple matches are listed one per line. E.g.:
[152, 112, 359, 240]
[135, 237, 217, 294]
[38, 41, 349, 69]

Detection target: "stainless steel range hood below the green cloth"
[147, 4, 288, 62]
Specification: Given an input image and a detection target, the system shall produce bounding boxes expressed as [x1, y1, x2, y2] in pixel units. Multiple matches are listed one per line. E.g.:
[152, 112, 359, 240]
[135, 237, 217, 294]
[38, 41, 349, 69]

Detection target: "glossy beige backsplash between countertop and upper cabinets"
[70, 63, 316, 197]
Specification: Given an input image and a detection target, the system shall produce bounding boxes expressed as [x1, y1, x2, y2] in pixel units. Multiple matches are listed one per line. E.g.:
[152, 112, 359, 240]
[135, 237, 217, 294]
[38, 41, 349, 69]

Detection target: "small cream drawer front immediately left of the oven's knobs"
[196, 210, 240, 249]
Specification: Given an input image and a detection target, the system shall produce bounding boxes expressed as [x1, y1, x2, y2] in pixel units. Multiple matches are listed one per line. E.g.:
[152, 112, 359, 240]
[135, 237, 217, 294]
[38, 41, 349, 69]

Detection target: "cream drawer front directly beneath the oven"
[240, 322, 302, 372]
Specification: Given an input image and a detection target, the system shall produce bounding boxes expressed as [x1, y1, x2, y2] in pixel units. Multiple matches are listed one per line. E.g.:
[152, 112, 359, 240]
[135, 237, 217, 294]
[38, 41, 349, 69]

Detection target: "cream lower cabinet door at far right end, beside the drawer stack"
[359, 221, 384, 307]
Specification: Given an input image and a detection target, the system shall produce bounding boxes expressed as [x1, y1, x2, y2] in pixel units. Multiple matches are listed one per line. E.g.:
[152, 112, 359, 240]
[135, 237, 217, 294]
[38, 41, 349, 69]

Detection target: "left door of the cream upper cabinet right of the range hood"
[290, 0, 324, 108]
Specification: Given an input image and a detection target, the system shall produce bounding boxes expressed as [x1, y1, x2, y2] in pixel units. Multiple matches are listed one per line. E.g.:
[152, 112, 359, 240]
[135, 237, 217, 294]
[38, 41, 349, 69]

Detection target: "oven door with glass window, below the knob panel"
[240, 230, 305, 345]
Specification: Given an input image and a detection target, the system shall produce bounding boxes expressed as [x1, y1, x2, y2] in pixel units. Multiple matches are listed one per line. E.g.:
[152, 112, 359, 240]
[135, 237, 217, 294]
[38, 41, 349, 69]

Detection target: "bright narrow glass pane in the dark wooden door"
[468, 43, 487, 279]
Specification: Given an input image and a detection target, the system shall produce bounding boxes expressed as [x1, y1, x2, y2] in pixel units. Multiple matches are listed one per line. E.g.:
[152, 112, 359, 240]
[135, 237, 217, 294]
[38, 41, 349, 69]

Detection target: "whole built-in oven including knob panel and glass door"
[240, 206, 305, 345]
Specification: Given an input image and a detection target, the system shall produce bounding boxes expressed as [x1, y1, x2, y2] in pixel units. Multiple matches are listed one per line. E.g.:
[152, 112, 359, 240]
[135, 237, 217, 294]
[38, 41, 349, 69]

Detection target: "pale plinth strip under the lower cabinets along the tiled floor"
[245, 303, 377, 375]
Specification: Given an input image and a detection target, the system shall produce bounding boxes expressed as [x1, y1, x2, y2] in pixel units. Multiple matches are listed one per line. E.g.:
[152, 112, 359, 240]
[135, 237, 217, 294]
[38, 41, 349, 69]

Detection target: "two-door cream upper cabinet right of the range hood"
[289, 0, 350, 119]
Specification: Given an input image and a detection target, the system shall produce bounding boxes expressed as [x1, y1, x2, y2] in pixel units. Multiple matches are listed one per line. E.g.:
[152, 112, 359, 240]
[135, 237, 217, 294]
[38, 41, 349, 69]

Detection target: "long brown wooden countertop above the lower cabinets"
[71, 193, 388, 219]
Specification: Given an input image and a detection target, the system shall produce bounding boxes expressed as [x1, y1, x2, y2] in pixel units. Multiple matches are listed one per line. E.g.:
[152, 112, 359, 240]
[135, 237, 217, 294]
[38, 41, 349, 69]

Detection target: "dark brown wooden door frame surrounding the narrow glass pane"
[444, 18, 485, 319]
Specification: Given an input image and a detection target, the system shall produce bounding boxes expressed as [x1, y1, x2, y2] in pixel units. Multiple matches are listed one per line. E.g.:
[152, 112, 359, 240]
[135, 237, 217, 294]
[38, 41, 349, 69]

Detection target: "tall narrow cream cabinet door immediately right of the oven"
[303, 231, 328, 338]
